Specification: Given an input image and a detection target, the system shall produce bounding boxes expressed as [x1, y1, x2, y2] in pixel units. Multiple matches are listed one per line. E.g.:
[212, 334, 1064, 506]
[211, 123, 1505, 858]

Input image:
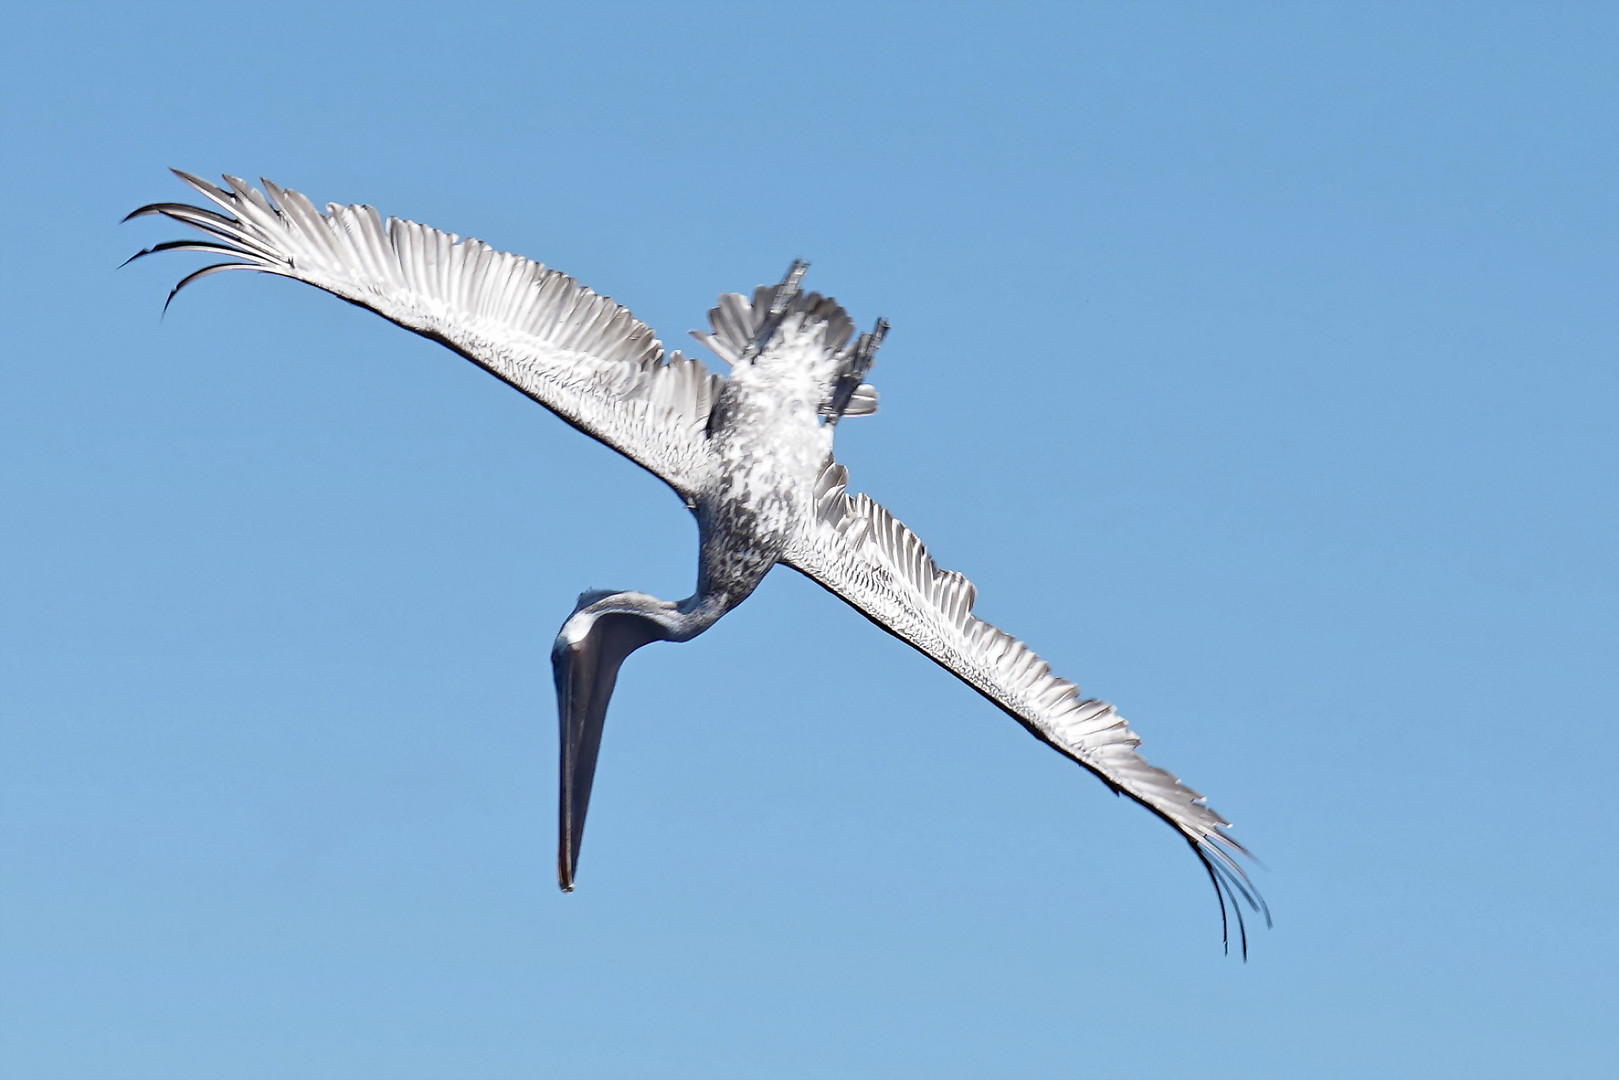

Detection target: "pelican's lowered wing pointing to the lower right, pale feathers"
[782, 460, 1269, 954]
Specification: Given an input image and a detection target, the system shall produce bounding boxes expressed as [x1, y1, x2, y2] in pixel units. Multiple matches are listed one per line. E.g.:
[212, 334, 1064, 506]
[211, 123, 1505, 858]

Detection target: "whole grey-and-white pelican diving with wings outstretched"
[125, 170, 1269, 955]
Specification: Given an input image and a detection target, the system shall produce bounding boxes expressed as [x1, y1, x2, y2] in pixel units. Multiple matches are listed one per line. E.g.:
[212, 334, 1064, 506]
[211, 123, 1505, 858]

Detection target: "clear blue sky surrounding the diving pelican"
[0, 3, 1619, 1080]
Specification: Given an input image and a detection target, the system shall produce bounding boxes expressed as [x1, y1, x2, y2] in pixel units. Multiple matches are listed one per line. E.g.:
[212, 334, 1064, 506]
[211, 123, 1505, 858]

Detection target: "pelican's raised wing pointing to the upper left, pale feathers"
[125, 170, 720, 500]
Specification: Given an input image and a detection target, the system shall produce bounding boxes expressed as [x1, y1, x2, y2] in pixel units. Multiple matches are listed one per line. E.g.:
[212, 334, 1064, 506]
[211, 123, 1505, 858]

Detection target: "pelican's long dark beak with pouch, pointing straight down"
[550, 614, 662, 892]
